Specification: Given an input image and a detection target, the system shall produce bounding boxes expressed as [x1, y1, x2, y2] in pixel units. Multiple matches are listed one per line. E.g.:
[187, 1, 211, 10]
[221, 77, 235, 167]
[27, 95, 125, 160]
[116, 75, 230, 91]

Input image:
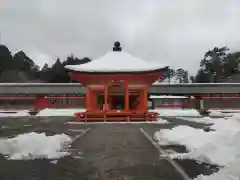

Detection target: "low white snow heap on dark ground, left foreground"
[0, 132, 71, 160]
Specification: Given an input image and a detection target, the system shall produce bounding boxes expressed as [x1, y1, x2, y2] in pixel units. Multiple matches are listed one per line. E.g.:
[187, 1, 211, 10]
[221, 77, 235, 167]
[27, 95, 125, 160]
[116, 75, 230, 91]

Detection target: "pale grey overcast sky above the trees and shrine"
[0, 0, 240, 73]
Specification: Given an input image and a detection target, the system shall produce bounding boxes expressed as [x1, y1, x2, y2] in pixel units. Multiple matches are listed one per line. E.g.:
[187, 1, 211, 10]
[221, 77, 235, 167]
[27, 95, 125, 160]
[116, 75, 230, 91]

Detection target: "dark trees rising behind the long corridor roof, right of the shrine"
[164, 46, 240, 83]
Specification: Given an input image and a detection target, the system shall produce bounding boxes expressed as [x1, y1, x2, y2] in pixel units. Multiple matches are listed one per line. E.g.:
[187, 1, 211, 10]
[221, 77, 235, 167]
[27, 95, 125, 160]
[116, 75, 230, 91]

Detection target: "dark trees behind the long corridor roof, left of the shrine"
[0, 45, 91, 83]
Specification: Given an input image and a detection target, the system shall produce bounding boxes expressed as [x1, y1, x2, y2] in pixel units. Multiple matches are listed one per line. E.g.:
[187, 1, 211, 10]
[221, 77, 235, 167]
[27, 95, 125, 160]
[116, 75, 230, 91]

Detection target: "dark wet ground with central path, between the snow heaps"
[0, 117, 218, 180]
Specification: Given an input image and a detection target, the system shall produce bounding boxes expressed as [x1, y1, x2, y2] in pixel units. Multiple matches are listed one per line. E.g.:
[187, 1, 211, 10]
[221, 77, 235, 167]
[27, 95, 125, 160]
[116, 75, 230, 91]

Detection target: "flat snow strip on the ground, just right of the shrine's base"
[149, 108, 201, 117]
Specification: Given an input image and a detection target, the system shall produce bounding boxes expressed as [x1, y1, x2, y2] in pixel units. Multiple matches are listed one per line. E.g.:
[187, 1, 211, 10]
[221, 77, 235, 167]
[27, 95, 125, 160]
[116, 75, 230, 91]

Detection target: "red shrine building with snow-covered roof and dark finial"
[65, 42, 168, 121]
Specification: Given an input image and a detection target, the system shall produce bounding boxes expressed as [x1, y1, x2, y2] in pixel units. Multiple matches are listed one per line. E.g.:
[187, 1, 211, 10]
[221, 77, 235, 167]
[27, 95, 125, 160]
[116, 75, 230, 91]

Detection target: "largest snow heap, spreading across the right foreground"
[154, 114, 240, 180]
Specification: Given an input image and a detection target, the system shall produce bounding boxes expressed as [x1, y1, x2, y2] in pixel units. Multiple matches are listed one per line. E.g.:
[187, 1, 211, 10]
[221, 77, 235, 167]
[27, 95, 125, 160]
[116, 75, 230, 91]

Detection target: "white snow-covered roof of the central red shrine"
[65, 51, 168, 72]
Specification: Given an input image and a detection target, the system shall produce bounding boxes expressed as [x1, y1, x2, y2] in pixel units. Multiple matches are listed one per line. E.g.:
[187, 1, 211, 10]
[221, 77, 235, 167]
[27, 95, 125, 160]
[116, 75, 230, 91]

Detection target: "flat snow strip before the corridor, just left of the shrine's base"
[36, 108, 85, 116]
